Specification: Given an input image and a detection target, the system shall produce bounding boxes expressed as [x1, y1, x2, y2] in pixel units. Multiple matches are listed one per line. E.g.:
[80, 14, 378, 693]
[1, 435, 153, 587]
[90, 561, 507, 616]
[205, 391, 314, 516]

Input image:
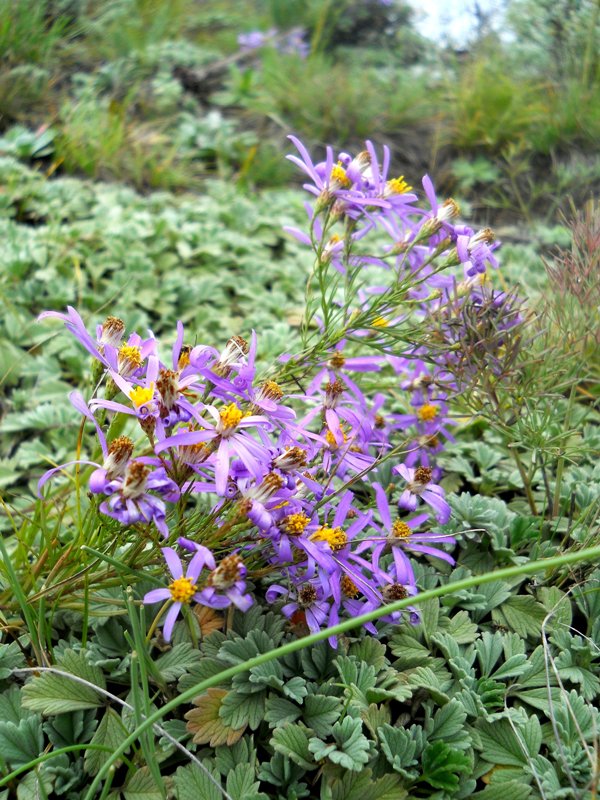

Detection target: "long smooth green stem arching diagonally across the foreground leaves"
[84, 547, 600, 800]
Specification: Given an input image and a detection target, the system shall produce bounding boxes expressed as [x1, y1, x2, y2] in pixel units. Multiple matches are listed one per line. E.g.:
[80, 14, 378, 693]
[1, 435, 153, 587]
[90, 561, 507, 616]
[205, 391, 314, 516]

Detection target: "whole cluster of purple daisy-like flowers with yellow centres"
[40, 137, 504, 643]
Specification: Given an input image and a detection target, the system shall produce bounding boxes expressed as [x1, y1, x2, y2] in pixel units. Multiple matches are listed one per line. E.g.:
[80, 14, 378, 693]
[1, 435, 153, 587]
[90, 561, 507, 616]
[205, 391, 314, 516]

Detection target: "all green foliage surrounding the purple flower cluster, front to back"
[0, 0, 600, 800]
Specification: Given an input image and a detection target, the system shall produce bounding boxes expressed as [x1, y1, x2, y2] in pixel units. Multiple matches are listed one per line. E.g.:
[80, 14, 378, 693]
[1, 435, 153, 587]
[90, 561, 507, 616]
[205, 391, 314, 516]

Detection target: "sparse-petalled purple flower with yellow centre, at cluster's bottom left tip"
[143, 545, 215, 642]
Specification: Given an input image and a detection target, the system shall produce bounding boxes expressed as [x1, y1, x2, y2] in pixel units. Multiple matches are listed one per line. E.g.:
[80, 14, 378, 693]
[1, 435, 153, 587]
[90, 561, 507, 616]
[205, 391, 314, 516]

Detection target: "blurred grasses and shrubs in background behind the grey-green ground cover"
[0, 0, 600, 223]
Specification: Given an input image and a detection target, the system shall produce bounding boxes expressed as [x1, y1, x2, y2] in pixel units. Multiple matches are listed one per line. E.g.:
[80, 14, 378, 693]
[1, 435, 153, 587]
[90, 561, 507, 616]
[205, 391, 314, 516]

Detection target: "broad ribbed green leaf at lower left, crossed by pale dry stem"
[23, 650, 106, 714]
